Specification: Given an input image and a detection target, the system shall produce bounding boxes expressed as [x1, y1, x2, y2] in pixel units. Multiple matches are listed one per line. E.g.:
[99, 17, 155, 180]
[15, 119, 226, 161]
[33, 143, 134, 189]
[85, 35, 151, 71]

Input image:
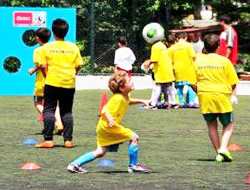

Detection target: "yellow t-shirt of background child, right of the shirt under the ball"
[170, 39, 196, 82]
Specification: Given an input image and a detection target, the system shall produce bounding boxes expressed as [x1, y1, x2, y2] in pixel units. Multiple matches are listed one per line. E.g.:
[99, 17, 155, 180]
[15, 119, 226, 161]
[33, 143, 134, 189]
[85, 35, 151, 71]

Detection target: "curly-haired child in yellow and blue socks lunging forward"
[67, 71, 150, 173]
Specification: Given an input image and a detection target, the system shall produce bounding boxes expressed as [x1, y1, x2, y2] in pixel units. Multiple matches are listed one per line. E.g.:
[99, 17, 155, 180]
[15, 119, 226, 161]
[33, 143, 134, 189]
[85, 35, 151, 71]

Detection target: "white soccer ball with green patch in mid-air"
[142, 22, 164, 44]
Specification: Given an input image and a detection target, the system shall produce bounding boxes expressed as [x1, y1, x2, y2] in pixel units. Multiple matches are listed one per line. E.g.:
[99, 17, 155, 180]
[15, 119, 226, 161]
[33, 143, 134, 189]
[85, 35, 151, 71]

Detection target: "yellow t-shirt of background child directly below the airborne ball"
[150, 41, 175, 83]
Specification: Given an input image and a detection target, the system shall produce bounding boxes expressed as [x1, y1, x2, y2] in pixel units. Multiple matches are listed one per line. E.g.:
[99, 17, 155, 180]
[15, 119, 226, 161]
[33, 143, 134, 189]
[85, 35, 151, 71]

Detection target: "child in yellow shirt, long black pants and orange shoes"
[35, 19, 83, 148]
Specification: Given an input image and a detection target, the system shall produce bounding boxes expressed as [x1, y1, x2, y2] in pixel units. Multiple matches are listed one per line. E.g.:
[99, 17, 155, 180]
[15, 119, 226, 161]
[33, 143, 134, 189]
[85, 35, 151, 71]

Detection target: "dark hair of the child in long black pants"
[52, 18, 69, 38]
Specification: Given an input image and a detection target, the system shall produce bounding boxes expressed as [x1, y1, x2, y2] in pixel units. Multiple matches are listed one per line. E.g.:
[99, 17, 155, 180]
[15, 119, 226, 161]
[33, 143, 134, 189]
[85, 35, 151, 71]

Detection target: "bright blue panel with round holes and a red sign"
[0, 7, 76, 95]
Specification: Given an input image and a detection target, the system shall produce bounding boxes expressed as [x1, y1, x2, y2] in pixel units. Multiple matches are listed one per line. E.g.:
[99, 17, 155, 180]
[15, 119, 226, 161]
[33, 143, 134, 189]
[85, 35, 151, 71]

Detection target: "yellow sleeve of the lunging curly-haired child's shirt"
[101, 95, 121, 116]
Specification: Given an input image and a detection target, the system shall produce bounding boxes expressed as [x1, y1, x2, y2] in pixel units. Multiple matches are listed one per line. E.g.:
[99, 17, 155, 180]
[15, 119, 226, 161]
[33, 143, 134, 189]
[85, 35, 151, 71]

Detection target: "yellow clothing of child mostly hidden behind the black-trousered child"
[33, 46, 45, 96]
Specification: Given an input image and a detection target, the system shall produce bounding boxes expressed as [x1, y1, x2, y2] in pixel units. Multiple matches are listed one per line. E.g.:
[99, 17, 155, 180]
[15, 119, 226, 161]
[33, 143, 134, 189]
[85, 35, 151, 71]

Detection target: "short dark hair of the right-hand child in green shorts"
[204, 33, 220, 53]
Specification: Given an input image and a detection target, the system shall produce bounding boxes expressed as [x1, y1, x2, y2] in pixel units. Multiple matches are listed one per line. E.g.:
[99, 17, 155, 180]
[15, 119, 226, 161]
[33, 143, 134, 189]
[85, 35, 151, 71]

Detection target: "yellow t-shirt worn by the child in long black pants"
[41, 41, 83, 88]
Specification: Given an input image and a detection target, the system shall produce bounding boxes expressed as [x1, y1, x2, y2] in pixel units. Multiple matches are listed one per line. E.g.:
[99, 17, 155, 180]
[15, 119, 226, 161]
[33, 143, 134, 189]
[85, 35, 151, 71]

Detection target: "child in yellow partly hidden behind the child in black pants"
[28, 28, 63, 135]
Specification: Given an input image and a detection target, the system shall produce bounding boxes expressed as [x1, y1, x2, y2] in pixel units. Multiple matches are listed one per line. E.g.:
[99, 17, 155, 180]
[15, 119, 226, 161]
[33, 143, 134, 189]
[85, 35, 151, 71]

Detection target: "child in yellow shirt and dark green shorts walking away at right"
[190, 34, 239, 162]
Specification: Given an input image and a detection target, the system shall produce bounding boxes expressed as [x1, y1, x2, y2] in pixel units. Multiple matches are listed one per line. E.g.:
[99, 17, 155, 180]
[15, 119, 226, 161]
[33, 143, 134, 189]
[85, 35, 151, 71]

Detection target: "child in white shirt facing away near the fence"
[114, 37, 136, 76]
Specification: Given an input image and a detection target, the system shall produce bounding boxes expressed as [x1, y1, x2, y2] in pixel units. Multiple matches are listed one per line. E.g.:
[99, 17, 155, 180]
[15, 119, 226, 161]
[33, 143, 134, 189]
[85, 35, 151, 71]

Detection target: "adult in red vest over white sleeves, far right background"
[218, 15, 238, 104]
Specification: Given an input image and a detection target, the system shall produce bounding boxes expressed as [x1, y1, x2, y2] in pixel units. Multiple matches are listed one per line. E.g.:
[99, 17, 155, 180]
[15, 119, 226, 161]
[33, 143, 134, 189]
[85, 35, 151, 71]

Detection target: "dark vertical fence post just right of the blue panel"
[90, 0, 95, 74]
